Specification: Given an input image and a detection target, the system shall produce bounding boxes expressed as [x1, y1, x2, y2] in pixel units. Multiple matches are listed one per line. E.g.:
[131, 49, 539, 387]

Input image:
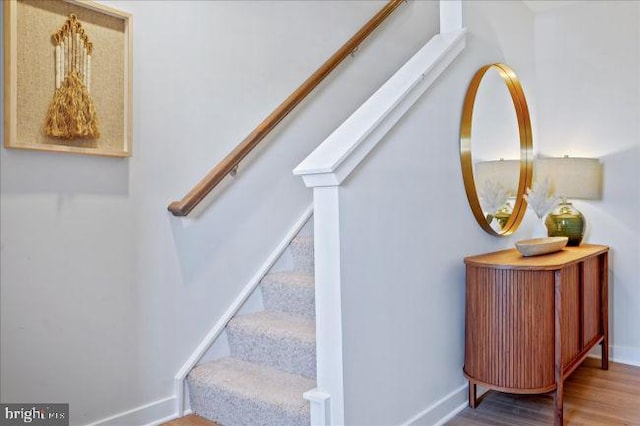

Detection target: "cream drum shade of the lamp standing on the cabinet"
[533, 157, 602, 200]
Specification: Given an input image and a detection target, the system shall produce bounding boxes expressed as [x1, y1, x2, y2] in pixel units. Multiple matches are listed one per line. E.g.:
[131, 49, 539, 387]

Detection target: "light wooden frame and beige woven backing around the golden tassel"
[2, 0, 133, 157]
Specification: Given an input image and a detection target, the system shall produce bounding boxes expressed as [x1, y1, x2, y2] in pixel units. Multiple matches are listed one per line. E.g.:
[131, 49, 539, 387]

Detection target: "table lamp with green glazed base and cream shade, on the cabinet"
[534, 155, 602, 246]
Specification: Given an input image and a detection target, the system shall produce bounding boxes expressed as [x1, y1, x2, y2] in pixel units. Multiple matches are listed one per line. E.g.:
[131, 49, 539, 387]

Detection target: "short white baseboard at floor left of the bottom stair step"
[88, 396, 177, 426]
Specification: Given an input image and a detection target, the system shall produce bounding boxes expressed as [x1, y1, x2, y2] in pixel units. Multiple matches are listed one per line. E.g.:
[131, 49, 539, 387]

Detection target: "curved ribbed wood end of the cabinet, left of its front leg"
[465, 267, 555, 393]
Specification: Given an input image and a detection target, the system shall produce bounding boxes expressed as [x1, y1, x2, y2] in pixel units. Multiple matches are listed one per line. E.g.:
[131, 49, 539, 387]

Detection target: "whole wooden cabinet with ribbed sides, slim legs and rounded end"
[464, 244, 609, 426]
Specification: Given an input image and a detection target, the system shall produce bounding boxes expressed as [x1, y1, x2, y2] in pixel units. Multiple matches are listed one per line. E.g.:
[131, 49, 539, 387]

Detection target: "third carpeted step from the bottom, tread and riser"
[261, 272, 315, 318]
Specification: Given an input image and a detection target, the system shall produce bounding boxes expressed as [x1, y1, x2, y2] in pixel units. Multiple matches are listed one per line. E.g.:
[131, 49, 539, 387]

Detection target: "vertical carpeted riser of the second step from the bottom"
[227, 327, 316, 379]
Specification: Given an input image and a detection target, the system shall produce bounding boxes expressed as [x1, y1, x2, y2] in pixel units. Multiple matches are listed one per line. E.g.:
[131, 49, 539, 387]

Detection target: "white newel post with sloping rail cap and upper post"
[293, 0, 465, 426]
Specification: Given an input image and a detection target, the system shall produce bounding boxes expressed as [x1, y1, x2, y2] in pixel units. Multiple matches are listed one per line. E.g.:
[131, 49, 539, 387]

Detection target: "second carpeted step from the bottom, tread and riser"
[227, 311, 316, 378]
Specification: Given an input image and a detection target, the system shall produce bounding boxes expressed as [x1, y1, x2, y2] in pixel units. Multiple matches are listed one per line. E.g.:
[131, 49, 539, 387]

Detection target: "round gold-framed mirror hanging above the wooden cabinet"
[460, 64, 533, 235]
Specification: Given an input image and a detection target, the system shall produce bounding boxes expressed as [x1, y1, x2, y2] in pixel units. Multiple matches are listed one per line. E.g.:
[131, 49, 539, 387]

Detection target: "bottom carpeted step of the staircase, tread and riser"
[188, 358, 316, 426]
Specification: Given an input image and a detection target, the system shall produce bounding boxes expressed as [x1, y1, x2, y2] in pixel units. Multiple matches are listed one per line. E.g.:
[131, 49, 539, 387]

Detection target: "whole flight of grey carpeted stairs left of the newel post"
[187, 235, 316, 426]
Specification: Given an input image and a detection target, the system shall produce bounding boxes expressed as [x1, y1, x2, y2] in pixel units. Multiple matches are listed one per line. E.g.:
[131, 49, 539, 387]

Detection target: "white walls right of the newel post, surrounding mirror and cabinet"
[340, 2, 640, 425]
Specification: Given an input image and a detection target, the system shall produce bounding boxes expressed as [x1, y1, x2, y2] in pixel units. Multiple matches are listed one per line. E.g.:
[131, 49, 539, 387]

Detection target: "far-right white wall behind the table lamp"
[535, 1, 640, 365]
